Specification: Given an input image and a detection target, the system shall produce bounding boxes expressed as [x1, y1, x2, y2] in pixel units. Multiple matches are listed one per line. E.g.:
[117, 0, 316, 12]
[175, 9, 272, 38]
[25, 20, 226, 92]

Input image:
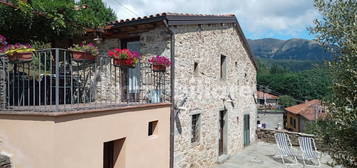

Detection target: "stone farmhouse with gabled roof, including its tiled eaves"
[97, 13, 257, 168]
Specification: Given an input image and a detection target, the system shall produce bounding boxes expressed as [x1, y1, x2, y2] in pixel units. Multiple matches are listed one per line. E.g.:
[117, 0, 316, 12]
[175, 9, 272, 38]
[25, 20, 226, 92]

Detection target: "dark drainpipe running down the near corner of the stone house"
[163, 20, 175, 168]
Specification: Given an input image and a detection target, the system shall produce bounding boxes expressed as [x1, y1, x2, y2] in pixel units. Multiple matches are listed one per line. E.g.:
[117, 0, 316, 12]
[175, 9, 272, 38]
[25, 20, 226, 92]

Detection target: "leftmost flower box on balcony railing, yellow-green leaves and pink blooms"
[2, 43, 35, 62]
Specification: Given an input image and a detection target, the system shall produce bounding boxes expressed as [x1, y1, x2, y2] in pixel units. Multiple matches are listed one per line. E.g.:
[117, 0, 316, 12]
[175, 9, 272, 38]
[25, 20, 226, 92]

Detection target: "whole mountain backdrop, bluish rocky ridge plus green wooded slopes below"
[248, 39, 332, 101]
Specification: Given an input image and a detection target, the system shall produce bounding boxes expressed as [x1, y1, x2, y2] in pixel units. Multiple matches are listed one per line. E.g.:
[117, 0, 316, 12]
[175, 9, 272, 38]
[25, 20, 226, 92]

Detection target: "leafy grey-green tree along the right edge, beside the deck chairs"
[311, 0, 357, 168]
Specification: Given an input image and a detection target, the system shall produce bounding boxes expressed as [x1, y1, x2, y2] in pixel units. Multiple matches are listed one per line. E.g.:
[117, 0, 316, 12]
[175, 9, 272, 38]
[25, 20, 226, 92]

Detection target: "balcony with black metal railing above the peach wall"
[0, 48, 171, 112]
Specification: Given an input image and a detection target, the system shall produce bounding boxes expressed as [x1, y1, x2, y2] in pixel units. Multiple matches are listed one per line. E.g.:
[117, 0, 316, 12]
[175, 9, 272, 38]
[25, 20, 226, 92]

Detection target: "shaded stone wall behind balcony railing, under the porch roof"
[93, 26, 170, 101]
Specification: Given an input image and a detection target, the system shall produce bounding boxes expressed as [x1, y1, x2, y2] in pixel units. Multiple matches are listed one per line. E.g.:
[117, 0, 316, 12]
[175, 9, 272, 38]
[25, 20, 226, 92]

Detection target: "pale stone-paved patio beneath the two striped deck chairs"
[216, 142, 337, 168]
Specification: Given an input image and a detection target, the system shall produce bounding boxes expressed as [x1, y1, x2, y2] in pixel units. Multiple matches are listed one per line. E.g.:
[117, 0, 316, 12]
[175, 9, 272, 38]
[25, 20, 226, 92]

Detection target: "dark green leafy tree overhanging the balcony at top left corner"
[0, 0, 116, 47]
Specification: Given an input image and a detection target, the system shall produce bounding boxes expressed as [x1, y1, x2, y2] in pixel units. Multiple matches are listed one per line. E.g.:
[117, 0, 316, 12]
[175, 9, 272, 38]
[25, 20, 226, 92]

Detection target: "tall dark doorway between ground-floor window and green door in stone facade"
[218, 110, 227, 156]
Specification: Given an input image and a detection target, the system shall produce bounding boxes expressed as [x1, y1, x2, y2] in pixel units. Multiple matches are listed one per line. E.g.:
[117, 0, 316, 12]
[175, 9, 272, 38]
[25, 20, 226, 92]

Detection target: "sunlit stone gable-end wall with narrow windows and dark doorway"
[172, 24, 257, 168]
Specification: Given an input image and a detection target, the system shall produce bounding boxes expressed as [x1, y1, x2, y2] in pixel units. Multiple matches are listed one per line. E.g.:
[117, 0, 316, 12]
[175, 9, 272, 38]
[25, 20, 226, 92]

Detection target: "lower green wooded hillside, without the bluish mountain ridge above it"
[257, 62, 331, 101]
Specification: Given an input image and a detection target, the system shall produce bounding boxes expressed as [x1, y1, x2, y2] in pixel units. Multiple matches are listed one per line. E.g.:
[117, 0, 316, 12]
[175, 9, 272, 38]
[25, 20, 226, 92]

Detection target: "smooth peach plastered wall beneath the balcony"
[0, 104, 170, 168]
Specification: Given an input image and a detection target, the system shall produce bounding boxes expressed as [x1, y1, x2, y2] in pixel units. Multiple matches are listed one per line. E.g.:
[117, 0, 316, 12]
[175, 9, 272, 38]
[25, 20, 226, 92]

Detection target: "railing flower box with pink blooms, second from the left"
[69, 43, 99, 62]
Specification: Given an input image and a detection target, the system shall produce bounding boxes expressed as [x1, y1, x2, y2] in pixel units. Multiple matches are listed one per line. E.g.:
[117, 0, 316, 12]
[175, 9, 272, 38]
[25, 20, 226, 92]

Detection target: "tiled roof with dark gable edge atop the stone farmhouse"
[105, 13, 258, 69]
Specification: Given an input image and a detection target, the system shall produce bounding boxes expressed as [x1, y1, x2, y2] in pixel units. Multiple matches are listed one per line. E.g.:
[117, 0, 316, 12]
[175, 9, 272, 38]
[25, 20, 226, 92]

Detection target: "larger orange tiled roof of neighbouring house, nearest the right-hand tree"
[285, 99, 325, 120]
